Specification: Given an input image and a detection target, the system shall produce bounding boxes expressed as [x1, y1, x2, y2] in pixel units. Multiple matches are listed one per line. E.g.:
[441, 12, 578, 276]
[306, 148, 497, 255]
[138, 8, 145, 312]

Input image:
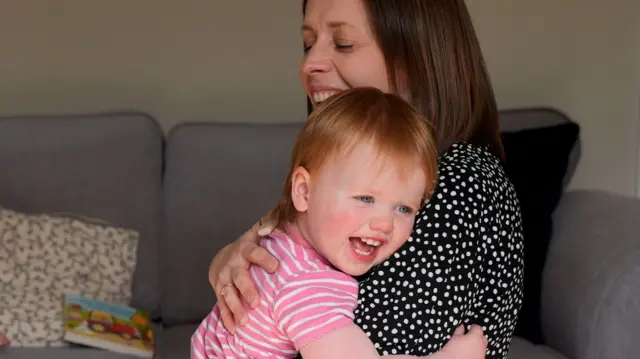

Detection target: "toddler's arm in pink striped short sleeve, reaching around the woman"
[273, 269, 487, 359]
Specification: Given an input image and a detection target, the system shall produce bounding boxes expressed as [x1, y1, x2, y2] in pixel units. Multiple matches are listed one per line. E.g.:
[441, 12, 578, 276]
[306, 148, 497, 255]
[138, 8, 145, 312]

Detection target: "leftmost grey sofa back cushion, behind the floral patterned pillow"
[0, 113, 163, 318]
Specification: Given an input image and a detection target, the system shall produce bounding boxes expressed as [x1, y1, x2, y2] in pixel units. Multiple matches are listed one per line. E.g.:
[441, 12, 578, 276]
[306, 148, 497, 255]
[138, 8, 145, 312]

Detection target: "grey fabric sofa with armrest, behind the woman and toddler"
[0, 110, 640, 359]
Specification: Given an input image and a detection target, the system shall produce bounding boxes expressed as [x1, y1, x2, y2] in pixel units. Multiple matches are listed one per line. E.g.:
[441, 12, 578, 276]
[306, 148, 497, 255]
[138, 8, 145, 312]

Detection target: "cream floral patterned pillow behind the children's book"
[0, 208, 138, 347]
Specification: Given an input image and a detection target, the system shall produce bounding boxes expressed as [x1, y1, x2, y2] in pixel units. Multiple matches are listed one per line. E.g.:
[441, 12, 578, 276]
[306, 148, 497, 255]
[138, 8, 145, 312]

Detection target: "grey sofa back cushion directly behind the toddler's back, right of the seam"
[162, 123, 301, 324]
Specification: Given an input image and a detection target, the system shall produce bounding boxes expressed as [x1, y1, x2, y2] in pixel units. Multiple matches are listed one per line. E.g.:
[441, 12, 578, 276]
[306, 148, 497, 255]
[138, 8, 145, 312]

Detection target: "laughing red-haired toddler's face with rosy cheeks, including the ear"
[291, 143, 427, 276]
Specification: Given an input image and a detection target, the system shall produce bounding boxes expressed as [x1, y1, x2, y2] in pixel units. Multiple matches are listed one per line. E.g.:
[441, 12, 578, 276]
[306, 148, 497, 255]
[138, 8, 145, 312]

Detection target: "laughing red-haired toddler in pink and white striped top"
[191, 88, 486, 359]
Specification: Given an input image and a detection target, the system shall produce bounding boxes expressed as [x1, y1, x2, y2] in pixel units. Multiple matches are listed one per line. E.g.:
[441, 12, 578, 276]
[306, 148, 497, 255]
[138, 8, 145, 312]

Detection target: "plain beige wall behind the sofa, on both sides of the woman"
[0, 0, 640, 195]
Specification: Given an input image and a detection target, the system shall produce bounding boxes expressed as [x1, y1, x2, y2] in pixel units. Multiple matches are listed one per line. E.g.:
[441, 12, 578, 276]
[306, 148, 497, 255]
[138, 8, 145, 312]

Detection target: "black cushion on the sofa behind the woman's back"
[503, 123, 579, 344]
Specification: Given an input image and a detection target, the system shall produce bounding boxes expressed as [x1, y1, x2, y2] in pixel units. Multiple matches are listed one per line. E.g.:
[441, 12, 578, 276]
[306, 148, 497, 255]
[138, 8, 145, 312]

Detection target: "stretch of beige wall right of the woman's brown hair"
[469, 0, 640, 194]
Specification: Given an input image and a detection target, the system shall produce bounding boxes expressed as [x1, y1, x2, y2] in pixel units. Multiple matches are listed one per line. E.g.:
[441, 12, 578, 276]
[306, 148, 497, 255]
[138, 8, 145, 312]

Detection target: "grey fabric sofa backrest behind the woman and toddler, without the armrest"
[0, 108, 580, 324]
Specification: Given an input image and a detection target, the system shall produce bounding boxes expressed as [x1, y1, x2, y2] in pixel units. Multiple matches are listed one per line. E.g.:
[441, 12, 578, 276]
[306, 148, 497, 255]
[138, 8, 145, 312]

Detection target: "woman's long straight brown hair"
[302, 0, 504, 159]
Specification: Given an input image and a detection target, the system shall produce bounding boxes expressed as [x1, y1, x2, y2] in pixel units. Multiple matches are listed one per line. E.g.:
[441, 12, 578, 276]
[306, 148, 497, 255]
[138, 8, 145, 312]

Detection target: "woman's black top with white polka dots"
[355, 143, 523, 359]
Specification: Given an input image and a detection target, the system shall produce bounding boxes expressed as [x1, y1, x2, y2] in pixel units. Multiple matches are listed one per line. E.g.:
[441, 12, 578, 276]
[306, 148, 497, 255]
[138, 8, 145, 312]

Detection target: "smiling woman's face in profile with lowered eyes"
[300, 0, 390, 106]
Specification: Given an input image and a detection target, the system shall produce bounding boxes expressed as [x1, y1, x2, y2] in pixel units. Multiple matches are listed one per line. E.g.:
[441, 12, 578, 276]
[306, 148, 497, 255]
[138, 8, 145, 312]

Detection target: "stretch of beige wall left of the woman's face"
[0, 0, 305, 128]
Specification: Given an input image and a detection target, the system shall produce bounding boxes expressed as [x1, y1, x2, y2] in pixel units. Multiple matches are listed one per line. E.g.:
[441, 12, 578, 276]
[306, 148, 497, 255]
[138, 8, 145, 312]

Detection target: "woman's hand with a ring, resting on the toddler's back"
[209, 220, 278, 333]
